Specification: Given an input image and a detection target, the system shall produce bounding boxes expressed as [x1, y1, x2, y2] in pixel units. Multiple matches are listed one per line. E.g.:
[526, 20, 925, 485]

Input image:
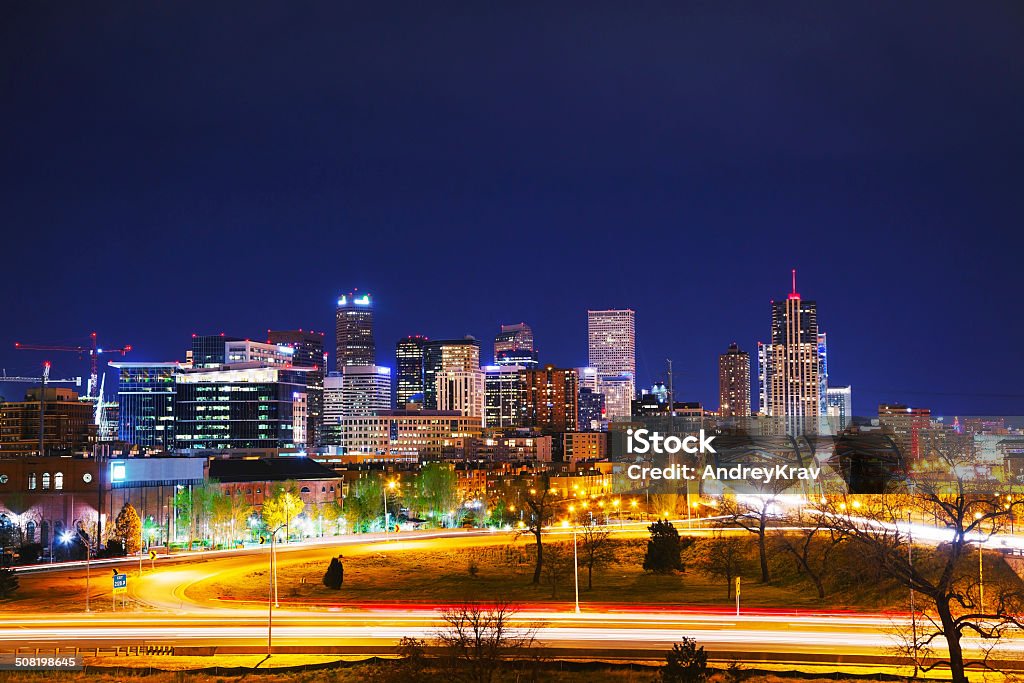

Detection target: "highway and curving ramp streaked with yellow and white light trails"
[0, 530, 1024, 664]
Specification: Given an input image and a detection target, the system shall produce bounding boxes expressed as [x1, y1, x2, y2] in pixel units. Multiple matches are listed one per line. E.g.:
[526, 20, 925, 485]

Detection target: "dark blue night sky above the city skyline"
[0, 0, 1024, 415]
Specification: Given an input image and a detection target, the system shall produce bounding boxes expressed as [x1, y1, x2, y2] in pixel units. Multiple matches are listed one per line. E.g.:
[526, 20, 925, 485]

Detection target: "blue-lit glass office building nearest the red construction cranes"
[110, 360, 181, 451]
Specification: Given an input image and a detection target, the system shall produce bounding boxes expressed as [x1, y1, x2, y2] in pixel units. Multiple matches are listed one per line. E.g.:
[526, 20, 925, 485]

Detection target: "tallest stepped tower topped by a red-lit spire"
[758, 270, 821, 434]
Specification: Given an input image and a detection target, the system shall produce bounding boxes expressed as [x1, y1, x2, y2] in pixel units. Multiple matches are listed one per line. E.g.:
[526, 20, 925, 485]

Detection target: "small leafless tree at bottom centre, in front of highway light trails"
[436, 602, 537, 683]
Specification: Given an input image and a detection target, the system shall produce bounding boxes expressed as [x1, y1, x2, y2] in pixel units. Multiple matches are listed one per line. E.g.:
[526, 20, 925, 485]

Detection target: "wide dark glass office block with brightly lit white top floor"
[174, 362, 309, 452]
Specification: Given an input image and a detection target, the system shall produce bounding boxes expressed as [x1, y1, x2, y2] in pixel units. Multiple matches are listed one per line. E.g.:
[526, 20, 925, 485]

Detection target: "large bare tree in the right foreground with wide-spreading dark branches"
[821, 444, 1024, 683]
